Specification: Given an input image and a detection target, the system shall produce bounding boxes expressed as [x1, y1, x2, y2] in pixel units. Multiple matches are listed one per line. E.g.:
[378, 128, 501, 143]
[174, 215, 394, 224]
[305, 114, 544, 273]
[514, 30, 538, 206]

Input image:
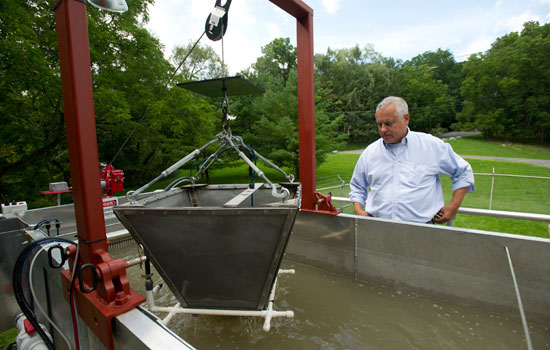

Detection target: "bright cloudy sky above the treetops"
[146, 0, 550, 75]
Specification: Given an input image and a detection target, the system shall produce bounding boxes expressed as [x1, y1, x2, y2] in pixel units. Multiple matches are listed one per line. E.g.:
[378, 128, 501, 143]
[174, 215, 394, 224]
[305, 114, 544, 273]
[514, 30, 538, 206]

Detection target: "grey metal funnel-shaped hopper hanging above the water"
[114, 184, 301, 310]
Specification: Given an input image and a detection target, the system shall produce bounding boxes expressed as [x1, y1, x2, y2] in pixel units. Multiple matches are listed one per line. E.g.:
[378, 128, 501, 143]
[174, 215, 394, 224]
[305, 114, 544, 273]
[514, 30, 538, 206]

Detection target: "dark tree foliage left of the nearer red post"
[0, 0, 67, 205]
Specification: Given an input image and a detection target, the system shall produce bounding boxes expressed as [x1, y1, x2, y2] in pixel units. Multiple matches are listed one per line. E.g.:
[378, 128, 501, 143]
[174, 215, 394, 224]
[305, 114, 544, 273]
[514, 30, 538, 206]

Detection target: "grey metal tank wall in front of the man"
[286, 212, 550, 325]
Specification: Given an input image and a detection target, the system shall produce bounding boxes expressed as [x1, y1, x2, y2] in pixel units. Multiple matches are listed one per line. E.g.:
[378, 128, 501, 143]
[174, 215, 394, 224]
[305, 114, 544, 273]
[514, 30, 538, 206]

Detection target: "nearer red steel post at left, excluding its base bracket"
[55, 0, 107, 264]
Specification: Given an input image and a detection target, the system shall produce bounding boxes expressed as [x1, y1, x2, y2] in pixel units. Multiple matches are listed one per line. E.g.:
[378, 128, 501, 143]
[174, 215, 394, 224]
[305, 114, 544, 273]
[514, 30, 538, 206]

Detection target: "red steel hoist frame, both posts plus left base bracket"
[55, 0, 315, 348]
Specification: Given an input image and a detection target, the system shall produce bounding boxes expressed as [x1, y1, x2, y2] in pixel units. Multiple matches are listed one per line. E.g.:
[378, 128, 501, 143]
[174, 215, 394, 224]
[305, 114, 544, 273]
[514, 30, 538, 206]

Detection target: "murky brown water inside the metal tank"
[112, 243, 550, 350]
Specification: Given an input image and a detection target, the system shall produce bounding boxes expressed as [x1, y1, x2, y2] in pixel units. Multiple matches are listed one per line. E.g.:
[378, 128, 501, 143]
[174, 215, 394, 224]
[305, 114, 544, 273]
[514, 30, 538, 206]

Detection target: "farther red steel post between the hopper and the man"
[270, 0, 316, 210]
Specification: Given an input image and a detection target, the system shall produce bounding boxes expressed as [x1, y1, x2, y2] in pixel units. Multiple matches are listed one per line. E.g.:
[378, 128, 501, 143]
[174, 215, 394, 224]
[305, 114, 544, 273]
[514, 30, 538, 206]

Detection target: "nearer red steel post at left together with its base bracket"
[55, 0, 145, 349]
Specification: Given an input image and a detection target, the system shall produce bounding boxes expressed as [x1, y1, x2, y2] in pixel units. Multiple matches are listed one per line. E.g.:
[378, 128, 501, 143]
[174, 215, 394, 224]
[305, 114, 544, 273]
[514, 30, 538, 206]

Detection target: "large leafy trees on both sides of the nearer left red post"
[0, 0, 220, 206]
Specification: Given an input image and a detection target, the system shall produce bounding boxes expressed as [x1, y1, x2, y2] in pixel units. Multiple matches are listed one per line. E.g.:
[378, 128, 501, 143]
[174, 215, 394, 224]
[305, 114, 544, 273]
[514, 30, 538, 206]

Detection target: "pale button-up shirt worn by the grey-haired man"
[349, 130, 475, 222]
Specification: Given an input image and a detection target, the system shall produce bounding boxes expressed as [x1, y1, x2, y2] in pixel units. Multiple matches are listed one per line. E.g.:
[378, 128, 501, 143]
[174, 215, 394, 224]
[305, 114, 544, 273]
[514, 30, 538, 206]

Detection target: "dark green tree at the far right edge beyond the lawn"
[458, 22, 550, 143]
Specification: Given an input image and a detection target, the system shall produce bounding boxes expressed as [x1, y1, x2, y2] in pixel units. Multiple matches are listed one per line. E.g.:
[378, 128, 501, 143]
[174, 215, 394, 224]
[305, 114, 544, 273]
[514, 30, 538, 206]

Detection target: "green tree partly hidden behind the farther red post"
[230, 38, 340, 175]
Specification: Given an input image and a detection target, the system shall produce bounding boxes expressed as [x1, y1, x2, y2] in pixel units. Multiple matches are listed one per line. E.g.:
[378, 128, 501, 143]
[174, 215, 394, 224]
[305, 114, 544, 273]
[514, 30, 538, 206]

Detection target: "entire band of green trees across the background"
[0, 0, 550, 206]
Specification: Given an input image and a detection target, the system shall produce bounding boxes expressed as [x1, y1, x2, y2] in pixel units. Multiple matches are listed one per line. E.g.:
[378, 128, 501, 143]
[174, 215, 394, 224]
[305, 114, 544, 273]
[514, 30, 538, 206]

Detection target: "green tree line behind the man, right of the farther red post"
[315, 22, 550, 144]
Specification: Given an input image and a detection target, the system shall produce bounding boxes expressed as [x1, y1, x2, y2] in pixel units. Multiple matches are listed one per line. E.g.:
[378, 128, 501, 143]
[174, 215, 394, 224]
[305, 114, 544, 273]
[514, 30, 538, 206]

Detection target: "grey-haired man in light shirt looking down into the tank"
[349, 96, 475, 224]
